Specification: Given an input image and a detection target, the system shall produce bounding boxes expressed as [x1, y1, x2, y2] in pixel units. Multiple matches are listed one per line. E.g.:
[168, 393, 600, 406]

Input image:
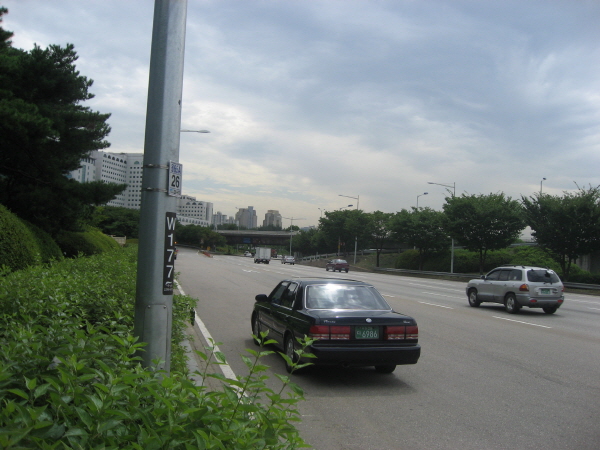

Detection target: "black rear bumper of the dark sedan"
[307, 344, 421, 366]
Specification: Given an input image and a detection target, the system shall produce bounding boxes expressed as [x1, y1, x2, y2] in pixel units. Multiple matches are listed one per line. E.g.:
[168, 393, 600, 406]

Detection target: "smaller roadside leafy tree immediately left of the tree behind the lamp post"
[391, 208, 450, 270]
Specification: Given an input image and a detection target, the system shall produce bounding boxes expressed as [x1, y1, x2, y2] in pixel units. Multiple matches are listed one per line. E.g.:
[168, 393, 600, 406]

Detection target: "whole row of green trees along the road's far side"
[292, 186, 600, 279]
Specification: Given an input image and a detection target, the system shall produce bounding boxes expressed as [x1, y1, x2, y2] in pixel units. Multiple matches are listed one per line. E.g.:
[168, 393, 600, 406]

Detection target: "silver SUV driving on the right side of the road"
[467, 266, 565, 314]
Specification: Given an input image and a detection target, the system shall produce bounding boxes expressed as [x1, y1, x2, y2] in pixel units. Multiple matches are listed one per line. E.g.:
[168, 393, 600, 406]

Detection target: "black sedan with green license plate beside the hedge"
[252, 278, 421, 373]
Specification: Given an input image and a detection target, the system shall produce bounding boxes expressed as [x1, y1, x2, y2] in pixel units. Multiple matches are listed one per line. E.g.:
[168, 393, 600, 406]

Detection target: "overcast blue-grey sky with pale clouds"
[0, 0, 600, 226]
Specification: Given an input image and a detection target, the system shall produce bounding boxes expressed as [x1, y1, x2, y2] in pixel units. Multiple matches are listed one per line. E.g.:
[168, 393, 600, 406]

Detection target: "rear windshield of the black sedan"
[306, 284, 392, 311]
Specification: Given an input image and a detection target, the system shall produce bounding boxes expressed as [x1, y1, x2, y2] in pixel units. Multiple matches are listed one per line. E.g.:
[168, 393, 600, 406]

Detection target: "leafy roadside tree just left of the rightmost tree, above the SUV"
[443, 193, 525, 273]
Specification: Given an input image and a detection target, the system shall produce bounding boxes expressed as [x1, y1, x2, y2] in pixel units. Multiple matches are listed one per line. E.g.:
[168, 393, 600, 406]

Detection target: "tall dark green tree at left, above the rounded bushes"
[0, 8, 126, 235]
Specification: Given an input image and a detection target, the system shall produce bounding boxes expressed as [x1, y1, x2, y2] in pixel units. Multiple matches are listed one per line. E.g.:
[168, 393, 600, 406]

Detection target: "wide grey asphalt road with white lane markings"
[176, 248, 600, 450]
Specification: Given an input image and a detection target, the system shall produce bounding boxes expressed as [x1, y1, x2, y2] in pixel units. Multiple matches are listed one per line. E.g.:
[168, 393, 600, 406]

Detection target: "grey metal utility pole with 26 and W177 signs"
[134, 0, 187, 373]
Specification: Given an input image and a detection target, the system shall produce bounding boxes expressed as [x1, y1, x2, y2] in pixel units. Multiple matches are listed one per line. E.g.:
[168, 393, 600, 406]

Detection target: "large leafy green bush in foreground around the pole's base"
[0, 246, 305, 450]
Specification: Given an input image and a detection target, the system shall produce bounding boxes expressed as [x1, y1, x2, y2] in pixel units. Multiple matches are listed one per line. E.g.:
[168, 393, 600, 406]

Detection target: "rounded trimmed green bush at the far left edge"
[0, 205, 42, 272]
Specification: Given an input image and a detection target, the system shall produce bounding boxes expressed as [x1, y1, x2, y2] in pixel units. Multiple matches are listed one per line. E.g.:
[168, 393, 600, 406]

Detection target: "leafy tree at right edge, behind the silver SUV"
[522, 186, 600, 280]
